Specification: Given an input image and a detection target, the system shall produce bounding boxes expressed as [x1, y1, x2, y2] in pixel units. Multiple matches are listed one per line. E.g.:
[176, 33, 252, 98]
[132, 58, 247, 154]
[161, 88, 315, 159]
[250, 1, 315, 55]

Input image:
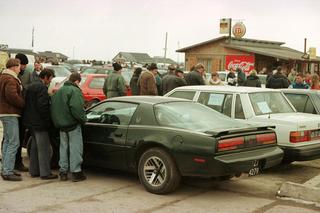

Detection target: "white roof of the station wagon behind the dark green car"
[171, 85, 280, 93]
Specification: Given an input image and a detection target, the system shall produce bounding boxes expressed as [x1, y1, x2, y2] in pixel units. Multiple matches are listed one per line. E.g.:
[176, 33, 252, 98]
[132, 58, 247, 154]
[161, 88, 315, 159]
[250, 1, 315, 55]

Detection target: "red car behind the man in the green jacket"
[53, 74, 131, 108]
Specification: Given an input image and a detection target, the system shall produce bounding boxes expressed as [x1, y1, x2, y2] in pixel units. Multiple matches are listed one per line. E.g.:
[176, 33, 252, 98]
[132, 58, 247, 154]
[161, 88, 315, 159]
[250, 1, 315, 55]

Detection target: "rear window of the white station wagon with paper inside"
[249, 92, 295, 115]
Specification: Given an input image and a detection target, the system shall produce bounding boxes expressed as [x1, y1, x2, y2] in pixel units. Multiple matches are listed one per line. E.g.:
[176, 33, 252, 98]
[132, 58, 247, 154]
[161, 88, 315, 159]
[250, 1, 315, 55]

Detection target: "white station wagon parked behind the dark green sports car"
[165, 86, 320, 162]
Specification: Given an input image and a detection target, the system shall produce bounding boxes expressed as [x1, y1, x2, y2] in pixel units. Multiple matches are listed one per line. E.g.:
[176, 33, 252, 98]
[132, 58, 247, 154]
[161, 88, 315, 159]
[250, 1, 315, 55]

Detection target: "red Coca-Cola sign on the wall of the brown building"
[226, 55, 255, 73]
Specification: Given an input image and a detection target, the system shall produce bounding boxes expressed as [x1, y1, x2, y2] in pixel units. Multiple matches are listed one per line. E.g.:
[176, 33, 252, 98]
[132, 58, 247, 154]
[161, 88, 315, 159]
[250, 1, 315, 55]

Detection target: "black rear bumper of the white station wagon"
[280, 144, 320, 161]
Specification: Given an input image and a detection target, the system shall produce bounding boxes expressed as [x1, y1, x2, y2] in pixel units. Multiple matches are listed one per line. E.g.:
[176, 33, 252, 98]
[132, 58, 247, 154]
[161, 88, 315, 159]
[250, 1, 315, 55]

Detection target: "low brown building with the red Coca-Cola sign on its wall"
[176, 36, 320, 73]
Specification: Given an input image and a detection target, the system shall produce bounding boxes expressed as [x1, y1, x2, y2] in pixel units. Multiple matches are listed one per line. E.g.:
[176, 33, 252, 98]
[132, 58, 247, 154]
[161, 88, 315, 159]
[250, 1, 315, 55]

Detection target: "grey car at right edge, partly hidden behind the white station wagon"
[281, 89, 320, 114]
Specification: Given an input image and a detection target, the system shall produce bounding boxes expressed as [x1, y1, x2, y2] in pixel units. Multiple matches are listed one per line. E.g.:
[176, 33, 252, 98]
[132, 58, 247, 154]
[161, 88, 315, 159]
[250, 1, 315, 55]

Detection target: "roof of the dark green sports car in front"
[106, 95, 191, 104]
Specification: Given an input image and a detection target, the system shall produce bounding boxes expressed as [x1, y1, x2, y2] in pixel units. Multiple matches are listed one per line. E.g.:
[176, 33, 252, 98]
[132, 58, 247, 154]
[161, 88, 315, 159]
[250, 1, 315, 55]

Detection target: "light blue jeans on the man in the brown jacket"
[0, 116, 20, 175]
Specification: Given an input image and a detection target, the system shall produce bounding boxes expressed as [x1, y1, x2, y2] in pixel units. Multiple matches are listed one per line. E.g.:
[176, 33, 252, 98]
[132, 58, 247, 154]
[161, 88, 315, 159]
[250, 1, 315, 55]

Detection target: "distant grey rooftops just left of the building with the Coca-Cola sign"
[112, 52, 176, 64]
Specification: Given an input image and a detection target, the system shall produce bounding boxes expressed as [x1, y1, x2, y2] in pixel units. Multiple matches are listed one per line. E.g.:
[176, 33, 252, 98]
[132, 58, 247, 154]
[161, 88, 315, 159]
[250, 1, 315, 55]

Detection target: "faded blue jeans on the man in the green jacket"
[59, 125, 83, 173]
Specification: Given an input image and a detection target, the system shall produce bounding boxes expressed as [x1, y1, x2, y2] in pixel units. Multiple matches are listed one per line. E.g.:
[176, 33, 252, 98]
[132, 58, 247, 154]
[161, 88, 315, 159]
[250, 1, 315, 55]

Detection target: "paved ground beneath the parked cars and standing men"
[0, 121, 320, 213]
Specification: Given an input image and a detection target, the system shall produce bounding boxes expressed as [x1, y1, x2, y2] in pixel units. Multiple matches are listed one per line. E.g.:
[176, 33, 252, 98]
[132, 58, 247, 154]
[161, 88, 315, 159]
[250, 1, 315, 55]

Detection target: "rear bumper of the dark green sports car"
[182, 147, 283, 177]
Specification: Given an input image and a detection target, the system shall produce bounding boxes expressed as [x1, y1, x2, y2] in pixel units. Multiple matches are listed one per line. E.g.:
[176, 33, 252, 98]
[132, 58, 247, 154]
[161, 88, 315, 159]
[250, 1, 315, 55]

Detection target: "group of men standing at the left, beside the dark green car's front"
[0, 53, 86, 182]
